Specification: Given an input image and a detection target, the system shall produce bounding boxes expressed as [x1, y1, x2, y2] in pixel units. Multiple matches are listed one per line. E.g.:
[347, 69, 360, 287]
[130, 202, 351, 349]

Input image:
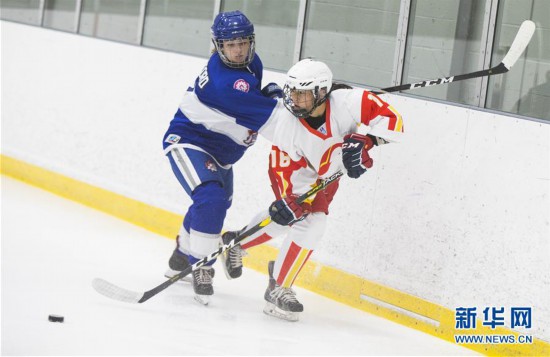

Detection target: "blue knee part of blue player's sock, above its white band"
[188, 181, 230, 234]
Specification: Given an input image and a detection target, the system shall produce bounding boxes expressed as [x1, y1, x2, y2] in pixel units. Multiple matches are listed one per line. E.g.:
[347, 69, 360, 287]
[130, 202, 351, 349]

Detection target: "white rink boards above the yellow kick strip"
[1, 21, 550, 341]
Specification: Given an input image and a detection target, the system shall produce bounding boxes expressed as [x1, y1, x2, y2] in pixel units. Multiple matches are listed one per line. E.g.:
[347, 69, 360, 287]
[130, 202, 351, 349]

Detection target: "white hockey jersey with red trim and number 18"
[260, 89, 403, 196]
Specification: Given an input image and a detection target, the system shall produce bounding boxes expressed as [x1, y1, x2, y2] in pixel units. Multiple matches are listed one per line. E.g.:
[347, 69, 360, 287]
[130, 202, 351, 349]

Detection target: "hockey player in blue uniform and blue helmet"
[163, 11, 282, 304]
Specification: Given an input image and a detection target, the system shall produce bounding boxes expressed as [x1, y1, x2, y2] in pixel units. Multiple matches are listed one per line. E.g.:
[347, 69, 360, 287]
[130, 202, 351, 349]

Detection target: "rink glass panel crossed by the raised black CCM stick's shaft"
[402, 0, 485, 105]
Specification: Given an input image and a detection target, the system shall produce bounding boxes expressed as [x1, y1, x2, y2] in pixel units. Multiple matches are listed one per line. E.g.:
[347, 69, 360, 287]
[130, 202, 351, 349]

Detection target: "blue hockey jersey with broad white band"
[164, 53, 277, 165]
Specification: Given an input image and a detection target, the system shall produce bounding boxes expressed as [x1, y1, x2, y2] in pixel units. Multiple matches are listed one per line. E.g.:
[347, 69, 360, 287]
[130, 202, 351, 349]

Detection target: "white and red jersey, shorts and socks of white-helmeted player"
[241, 85, 403, 296]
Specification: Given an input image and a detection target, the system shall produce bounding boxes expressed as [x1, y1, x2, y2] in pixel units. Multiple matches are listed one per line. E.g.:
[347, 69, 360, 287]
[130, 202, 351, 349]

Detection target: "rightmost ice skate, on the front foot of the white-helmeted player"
[264, 261, 304, 321]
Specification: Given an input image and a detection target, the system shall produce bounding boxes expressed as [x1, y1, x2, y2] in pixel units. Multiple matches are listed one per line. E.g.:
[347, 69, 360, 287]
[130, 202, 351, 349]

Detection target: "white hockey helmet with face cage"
[283, 58, 332, 118]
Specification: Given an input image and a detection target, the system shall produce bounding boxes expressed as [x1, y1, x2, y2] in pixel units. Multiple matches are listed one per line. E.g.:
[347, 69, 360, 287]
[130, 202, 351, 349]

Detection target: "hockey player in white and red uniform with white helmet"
[222, 59, 403, 321]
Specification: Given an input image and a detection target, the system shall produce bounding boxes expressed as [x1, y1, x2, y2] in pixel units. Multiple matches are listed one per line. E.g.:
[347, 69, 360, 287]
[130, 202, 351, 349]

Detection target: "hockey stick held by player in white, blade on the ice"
[92, 171, 343, 304]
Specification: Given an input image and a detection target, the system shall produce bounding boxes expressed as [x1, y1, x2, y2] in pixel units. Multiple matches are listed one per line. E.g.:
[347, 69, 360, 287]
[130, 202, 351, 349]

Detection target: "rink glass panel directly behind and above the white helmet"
[301, 0, 400, 87]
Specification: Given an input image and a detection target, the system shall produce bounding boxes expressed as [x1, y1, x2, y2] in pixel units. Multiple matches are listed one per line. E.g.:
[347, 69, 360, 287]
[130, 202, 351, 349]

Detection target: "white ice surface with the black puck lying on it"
[1, 176, 475, 356]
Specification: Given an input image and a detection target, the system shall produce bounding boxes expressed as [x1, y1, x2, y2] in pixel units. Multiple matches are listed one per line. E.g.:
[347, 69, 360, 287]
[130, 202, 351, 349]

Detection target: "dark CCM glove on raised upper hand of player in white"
[342, 134, 374, 178]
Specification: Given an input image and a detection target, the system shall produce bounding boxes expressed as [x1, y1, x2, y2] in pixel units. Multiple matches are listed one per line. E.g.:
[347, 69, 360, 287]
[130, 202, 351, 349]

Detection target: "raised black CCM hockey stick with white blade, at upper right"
[373, 20, 535, 94]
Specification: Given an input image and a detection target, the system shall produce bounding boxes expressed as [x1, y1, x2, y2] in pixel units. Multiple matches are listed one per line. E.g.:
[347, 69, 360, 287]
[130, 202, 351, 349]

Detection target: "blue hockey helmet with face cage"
[210, 10, 255, 68]
